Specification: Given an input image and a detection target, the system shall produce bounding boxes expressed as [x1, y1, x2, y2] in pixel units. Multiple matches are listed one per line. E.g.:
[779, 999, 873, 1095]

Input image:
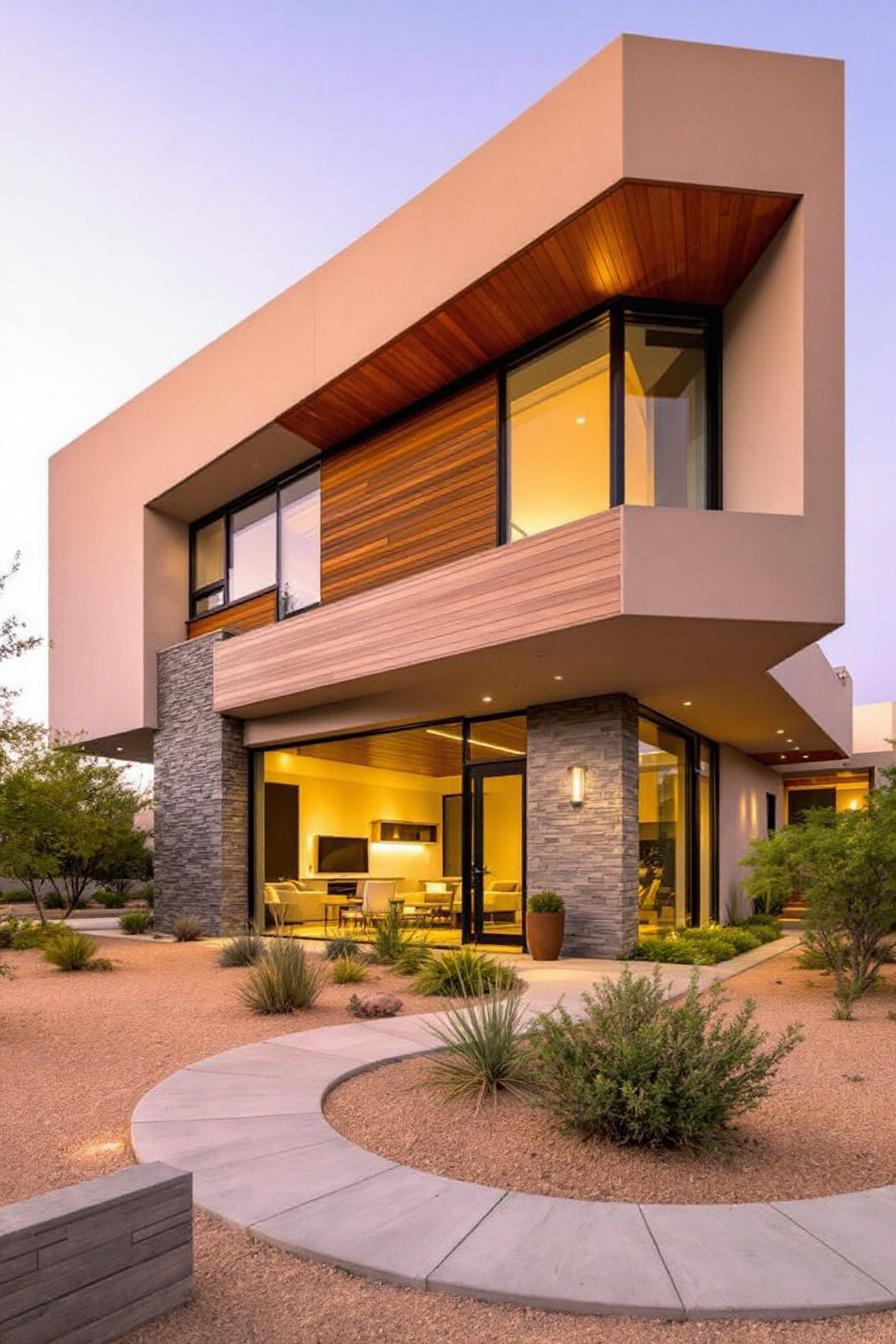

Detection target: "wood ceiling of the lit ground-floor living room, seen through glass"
[294, 716, 525, 778]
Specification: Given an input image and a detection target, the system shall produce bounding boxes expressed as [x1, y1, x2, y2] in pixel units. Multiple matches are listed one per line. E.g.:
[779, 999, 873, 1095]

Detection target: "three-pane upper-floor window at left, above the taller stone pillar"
[191, 466, 321, 617]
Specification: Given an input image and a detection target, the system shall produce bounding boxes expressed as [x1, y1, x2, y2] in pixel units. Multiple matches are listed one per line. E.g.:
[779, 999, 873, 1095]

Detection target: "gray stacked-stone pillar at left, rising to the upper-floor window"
[153, 630, 249, 934]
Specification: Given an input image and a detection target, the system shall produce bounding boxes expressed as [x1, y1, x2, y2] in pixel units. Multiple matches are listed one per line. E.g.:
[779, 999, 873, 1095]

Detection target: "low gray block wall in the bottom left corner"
[0, 1163, 192, 1344]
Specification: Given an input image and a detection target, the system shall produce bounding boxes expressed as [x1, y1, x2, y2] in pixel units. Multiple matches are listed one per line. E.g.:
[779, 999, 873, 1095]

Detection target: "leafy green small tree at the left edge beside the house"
[0, 738, 146, 919]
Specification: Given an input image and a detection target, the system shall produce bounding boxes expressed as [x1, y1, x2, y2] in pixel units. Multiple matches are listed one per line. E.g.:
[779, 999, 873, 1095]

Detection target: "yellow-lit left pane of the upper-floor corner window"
[506, 319, 610, 542]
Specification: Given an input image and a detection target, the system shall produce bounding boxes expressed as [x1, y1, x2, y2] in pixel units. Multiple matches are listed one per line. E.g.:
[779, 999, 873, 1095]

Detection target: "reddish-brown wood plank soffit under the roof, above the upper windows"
[279, 181, 799, 448]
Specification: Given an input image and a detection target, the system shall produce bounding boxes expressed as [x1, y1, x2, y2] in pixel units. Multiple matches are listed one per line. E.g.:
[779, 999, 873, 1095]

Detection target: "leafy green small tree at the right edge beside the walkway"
[743, 770, 896, 1017]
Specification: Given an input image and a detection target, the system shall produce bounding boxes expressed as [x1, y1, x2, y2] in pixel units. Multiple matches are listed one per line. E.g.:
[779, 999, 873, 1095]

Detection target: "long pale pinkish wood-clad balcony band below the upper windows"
[215, 509, 621, 714]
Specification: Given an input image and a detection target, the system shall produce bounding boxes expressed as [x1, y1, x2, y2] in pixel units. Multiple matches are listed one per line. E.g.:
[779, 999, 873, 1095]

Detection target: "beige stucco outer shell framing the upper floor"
[50, 36, 849, 758]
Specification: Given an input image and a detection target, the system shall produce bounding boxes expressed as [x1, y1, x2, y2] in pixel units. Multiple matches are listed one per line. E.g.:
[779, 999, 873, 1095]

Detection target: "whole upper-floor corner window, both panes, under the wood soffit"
[504, 300, 720, 542]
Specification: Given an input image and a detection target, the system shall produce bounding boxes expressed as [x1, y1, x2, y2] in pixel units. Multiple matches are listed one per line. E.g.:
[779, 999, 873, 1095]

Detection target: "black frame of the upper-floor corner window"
[497, 296, 723, 546]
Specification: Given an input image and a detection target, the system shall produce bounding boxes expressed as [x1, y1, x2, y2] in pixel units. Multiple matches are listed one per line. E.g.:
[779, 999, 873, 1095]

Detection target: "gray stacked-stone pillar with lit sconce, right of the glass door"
[527, 695, 638, 957]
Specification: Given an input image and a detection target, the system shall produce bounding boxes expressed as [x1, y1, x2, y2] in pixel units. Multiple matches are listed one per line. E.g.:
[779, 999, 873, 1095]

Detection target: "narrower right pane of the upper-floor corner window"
[625, 317, 707, 508]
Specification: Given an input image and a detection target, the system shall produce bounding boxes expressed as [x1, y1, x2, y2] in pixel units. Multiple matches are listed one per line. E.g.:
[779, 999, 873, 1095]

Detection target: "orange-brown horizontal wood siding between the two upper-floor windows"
[321, 378, 497, 602]
